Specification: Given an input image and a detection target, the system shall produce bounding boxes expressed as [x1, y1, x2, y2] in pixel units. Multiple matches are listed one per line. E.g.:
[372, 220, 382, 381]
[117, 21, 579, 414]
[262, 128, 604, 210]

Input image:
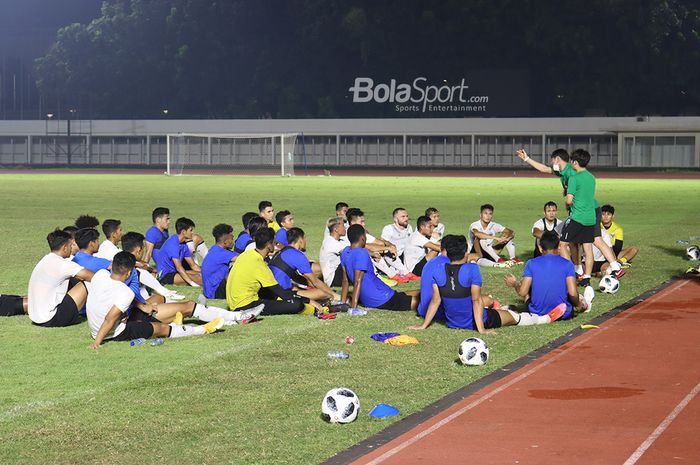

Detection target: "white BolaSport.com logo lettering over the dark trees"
[348, 77, 489, 113]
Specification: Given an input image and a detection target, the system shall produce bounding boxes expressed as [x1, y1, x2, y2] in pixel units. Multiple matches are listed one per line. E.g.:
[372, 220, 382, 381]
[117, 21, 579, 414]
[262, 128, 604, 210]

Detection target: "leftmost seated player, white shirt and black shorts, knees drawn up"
[27, 229, 93, 327]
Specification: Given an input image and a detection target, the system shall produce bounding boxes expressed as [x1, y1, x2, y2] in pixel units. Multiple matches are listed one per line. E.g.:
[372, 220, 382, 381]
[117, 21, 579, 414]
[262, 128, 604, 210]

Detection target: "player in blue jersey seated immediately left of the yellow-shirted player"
[202, 224, 239, 299]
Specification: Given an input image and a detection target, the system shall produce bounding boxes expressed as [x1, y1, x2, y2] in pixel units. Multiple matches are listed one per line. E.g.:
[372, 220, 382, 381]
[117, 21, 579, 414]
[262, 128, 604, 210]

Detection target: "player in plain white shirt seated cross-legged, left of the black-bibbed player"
[469, 203, 522, 266]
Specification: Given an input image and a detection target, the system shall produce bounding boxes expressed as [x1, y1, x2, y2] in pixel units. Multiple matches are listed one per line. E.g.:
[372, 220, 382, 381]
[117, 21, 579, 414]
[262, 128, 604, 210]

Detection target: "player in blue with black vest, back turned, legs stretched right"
[410, 235, 563, 334]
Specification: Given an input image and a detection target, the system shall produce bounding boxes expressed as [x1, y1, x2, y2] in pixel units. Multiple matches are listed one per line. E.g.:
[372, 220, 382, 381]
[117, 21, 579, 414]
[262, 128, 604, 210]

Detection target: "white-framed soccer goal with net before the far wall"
[165, 133, 297, 176]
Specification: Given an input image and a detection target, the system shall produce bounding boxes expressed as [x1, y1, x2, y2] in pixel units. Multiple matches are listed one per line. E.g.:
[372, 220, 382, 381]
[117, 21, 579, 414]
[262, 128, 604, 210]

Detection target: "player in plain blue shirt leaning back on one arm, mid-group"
[340, 224, 420, 310]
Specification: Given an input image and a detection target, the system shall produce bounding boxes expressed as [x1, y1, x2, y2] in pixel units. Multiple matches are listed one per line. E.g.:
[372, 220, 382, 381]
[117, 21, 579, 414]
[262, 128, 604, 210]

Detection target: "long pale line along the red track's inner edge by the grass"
[367, 281, 688, 465]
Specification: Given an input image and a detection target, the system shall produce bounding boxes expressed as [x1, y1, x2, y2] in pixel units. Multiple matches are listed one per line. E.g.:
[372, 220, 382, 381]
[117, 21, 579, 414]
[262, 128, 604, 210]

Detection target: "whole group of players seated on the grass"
[0, 170, 637, 340]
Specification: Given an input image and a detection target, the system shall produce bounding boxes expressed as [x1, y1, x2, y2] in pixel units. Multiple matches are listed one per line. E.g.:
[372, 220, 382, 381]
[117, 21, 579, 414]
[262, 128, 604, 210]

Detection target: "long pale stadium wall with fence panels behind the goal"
[0, 117, 700, 168]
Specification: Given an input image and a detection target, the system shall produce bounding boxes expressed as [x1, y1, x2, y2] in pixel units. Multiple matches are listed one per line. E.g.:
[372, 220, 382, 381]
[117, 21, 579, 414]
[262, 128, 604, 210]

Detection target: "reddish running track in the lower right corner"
[327, 276, 700, 465]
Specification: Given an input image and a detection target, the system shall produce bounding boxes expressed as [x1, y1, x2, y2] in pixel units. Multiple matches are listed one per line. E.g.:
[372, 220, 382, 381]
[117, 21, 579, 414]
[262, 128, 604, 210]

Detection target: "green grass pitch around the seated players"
[0, 174, 700, 464]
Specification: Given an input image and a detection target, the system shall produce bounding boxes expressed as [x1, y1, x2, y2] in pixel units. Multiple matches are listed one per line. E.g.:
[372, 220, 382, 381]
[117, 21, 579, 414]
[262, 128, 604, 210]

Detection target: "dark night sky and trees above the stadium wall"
[0, 0, 700, 119]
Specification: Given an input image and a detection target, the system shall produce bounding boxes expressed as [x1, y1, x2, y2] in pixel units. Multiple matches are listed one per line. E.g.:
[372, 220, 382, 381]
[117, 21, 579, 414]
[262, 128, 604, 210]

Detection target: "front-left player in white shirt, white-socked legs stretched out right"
[87, 252, 224, 349]
